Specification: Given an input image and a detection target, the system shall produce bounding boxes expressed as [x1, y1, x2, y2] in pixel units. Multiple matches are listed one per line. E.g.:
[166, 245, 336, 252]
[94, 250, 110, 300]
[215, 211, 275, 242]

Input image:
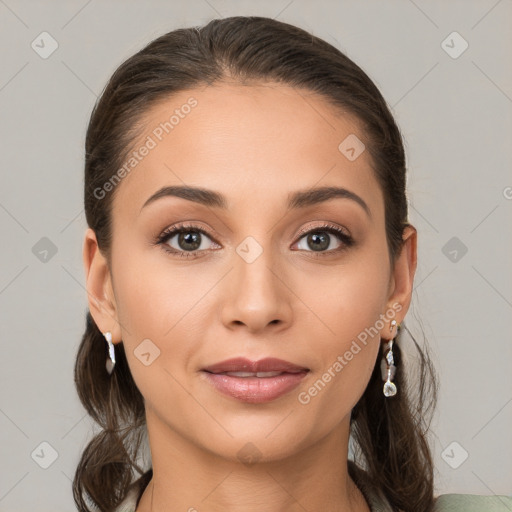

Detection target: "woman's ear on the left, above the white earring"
[82, 228, 121, 343]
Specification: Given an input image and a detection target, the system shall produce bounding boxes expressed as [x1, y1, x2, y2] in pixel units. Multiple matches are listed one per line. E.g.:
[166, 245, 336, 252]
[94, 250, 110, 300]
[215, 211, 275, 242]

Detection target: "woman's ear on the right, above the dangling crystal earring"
[388, 224, 417, 334]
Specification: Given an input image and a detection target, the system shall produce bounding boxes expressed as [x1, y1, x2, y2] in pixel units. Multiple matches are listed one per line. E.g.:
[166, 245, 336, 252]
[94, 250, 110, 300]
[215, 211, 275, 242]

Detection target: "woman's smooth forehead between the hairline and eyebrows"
[114, 83, 382, 219]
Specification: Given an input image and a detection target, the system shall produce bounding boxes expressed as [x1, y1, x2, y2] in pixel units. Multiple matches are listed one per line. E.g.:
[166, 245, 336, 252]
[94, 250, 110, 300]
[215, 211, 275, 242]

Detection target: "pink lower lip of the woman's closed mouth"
[203, 371, 308, 404]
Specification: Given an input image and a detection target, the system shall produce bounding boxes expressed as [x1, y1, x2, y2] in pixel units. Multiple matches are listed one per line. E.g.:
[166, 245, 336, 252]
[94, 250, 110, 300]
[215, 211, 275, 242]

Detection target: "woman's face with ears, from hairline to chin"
[84, 80, 415, 460]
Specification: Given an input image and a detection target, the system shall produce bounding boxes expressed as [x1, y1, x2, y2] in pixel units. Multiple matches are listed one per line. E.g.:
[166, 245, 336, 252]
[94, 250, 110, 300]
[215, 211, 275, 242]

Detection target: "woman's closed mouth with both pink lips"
[202, 358, 310, 404]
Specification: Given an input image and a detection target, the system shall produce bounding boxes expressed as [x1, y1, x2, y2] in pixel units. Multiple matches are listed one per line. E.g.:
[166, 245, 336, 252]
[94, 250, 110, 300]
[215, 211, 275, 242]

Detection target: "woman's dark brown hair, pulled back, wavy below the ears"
[73, 16, 437, 512]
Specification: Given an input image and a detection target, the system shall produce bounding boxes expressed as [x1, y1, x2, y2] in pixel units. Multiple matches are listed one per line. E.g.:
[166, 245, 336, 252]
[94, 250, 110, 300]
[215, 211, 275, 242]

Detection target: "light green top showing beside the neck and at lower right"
[115, 460, 512, 512]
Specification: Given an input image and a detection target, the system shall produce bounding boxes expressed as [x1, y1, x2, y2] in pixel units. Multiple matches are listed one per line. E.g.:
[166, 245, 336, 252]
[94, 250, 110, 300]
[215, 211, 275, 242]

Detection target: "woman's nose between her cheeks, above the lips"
[222, 242, 293, 334]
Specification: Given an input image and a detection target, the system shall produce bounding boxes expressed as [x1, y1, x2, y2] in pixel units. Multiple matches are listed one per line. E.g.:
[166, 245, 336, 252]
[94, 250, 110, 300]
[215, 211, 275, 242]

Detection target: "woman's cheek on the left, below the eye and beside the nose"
[113, 247, 213, 394]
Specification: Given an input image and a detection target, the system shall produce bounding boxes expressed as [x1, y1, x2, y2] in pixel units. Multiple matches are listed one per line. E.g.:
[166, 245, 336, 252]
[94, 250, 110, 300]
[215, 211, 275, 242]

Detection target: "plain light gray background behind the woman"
[0, 0, 512, 512]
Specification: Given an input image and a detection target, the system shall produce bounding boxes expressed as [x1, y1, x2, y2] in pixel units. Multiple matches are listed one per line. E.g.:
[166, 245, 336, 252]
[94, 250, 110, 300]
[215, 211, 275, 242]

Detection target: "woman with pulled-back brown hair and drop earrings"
[74, 17, 511, 512]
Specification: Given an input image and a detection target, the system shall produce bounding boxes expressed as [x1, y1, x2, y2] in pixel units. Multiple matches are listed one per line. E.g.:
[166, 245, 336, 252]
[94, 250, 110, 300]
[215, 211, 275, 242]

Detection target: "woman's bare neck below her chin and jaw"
[136, 411, 370, 512]
